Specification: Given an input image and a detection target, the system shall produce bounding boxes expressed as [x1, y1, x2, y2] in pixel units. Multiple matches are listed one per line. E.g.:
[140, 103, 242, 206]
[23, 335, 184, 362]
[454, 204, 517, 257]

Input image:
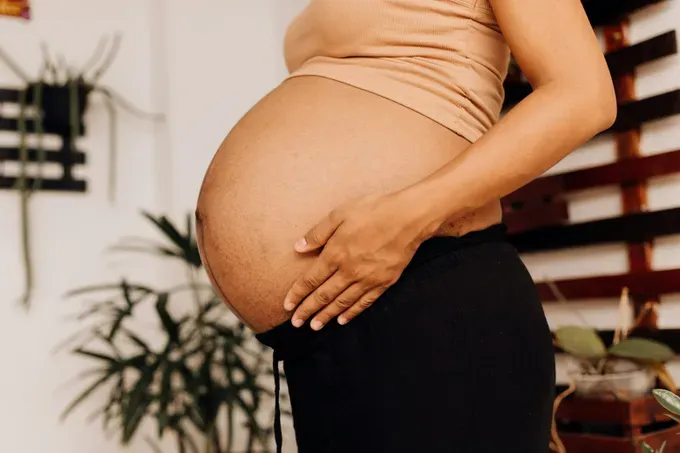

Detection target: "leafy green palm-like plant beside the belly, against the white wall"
[63, 213, 282, 453]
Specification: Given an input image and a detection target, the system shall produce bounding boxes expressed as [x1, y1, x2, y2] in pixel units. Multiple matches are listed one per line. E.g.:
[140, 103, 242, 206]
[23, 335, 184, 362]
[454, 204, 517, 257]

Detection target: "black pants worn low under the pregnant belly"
[258, 225, 555, 453]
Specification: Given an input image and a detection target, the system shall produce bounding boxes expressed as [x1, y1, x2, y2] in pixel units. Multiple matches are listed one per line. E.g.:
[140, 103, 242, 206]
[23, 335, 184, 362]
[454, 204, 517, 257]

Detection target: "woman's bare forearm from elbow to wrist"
[408, 83, 616, 233]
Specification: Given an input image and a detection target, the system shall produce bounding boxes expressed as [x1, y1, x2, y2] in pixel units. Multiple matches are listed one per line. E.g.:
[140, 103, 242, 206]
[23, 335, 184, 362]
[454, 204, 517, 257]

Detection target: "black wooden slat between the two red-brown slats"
[508, 208, 680, 253]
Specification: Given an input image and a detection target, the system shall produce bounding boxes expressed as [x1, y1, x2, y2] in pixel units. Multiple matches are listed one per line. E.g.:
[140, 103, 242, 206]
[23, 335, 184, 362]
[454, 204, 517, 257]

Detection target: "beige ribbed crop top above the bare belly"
[285, 0, 510, 142]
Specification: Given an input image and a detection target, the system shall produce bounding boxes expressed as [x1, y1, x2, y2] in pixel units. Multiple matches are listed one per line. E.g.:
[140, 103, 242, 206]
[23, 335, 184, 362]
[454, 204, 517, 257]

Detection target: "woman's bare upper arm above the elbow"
[490, 0, 612, 92]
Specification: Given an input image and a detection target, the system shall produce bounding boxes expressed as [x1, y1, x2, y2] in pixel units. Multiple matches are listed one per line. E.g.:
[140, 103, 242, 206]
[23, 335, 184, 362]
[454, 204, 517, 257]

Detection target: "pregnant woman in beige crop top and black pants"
[197, 0, 616, 453]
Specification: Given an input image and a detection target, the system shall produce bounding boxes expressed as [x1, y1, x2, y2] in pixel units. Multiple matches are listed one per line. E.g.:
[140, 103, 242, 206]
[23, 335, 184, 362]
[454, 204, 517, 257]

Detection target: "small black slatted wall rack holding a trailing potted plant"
[0, 32, 162, 307]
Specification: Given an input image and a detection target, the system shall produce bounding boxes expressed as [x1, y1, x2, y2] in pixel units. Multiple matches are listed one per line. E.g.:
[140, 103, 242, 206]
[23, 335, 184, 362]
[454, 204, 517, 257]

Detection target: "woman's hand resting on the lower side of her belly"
[284, 191, 435, 330]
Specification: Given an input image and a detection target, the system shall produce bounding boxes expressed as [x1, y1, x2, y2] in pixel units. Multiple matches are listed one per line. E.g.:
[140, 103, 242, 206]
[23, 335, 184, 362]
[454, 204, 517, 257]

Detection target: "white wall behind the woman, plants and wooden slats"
[0, 0, 680, 453]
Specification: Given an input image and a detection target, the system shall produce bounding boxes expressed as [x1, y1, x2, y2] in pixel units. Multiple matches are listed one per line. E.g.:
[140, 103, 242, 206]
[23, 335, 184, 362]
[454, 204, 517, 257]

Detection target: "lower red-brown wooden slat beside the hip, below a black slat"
[536, 269, 680, 302]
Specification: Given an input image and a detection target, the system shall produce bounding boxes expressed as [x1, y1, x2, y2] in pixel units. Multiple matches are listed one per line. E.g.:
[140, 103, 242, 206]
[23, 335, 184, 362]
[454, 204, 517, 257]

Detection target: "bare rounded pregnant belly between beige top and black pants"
[197, 77, 501, 332]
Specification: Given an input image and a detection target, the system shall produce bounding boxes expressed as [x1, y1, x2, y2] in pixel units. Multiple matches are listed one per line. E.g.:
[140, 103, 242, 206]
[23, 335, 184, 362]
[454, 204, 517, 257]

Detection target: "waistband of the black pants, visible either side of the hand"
[256, 223, 507, 360]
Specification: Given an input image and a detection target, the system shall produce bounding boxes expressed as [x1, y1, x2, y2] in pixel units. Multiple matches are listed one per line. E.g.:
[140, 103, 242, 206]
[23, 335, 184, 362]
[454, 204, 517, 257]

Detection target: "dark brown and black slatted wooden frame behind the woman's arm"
[503, 0, 680, 453]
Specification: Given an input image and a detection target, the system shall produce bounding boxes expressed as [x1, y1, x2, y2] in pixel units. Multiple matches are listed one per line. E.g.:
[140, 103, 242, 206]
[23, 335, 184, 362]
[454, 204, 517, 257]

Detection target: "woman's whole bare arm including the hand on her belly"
[284, 0, 616, 329]
